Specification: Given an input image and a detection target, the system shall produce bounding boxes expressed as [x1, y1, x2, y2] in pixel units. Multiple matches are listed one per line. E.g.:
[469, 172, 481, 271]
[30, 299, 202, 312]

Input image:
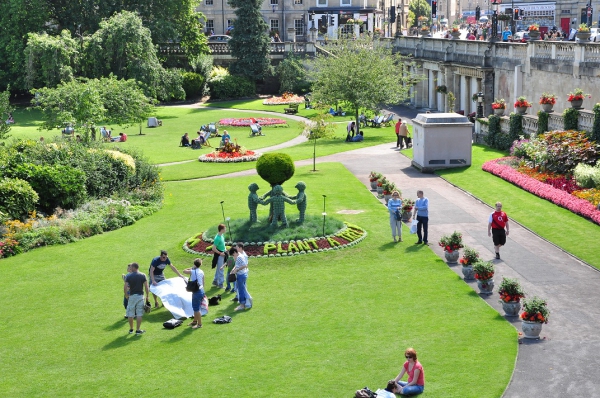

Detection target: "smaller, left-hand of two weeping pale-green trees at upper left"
[25, 29, 79, 88]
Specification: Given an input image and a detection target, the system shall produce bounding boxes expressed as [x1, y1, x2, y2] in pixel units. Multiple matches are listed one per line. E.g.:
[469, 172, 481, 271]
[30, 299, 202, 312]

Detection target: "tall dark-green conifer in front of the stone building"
[229, 0, 273, 81]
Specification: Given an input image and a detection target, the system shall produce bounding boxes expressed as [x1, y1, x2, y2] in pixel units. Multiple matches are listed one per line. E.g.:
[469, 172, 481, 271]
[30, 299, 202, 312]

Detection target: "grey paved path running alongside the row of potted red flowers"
[173, 103, 600, 398]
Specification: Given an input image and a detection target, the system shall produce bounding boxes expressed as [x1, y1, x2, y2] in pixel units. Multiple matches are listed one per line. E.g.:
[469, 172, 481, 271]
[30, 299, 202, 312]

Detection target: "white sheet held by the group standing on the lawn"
[150, 277, 208, 319]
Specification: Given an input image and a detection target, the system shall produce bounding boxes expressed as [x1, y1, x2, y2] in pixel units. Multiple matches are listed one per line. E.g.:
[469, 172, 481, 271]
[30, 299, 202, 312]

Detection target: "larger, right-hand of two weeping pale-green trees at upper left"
[85, 11, 185, 100]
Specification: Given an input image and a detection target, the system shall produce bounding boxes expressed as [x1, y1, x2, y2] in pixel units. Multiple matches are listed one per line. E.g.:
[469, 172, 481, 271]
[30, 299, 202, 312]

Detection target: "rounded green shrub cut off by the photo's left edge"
[0, 178, 39, 220]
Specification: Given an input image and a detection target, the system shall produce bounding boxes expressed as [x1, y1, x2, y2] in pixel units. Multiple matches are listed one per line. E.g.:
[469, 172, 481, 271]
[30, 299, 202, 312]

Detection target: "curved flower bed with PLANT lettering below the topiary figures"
[183, 223, 367, 258]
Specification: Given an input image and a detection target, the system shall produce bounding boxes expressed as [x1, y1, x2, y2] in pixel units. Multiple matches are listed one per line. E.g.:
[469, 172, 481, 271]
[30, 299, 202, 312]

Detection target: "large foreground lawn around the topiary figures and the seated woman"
[0, 164, 518, 398]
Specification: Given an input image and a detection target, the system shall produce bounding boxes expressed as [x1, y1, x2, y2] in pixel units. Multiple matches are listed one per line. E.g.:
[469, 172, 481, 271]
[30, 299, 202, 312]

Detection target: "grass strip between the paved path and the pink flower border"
[437, 145, 600, 269]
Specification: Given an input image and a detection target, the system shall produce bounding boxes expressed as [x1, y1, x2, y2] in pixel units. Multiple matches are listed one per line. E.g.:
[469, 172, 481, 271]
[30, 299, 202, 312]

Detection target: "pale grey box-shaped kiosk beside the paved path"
[412, 113, 473, 173]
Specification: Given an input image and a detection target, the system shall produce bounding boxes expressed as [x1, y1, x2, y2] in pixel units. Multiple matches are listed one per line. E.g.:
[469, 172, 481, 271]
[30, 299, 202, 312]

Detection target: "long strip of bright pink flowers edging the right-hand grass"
[482, 158, 600, 225]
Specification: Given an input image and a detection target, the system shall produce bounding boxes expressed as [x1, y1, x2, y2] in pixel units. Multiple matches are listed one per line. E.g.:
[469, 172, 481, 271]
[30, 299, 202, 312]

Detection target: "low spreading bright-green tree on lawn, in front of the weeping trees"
[32, 76, 153, 142]
